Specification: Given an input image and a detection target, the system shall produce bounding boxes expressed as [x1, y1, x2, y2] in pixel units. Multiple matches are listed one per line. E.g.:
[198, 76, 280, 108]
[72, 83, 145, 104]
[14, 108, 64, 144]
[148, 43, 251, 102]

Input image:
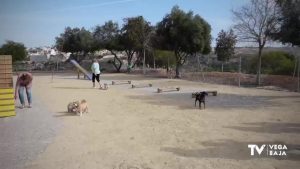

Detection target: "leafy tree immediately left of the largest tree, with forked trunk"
[121, 16, 151, 72]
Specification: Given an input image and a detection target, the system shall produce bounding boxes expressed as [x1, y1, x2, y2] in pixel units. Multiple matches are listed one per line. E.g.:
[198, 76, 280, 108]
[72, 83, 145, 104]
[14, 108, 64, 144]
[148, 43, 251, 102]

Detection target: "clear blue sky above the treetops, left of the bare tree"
[0, 0, 250, 47]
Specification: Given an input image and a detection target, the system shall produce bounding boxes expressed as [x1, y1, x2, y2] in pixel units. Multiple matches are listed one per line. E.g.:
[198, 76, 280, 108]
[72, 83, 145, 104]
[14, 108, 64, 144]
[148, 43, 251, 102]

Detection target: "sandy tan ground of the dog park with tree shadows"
[0, 74, 300, 169]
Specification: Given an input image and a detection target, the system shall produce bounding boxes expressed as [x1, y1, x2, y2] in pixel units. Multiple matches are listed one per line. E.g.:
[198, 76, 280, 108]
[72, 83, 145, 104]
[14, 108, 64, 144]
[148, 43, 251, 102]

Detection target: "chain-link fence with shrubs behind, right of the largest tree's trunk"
[182, 55, 298, 91]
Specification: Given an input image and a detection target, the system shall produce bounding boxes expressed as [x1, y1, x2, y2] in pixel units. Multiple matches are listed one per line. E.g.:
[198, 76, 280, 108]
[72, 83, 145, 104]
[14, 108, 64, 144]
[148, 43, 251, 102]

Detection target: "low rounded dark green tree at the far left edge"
[0, 41, 27, 62]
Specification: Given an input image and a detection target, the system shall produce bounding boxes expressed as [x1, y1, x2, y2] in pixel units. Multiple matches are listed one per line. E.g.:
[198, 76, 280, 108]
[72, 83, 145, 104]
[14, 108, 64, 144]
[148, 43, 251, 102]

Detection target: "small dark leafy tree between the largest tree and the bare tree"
[215, 29, 237, 72]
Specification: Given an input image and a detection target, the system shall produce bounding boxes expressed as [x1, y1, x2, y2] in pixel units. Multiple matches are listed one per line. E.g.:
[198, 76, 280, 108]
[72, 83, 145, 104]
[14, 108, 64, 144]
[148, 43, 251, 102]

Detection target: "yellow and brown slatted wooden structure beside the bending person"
[0, 55, 16, 117]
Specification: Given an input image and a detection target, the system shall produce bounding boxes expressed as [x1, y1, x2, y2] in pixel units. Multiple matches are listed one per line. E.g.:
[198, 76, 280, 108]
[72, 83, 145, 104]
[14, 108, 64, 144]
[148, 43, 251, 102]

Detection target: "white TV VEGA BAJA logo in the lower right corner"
[248, 144, 287, 156]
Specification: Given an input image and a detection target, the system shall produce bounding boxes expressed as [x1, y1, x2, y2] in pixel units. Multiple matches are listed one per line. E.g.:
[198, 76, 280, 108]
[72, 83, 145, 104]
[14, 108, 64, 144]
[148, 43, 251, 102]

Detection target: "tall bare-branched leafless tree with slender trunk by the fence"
[232, 0, 279, 85]
